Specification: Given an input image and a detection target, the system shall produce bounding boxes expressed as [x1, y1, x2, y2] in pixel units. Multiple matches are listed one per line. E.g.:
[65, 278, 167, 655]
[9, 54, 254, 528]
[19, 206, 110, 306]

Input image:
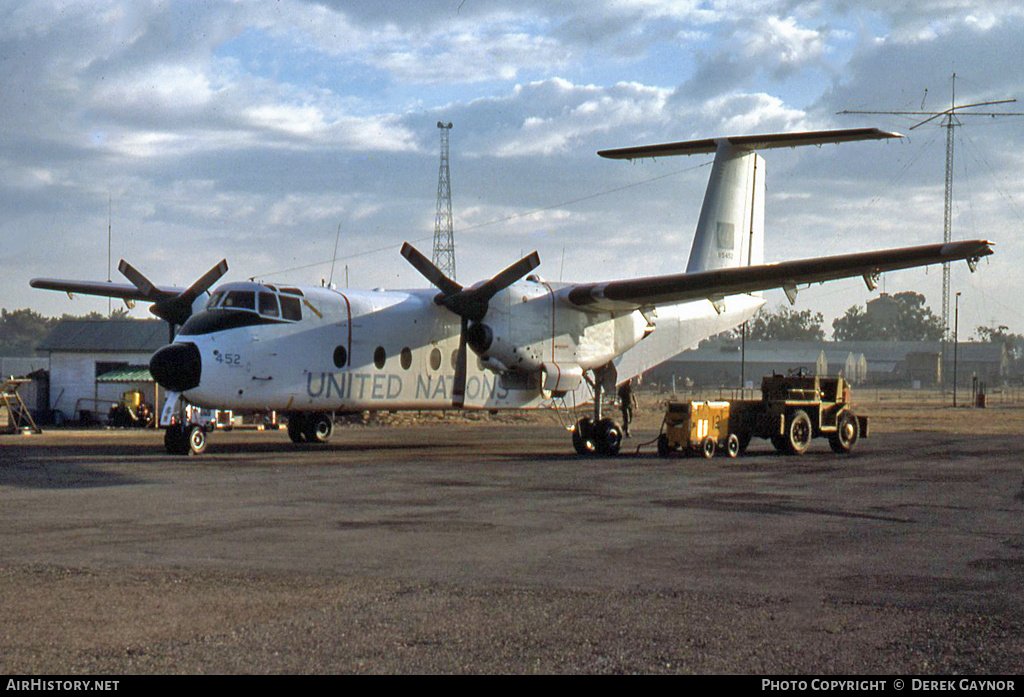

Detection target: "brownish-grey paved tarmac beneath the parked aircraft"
[0, 423, 1024, 676]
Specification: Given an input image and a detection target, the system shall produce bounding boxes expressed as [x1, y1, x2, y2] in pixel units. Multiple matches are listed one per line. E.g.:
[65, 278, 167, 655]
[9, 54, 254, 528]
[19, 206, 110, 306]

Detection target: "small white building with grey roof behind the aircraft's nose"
[37, 319, 169, 421]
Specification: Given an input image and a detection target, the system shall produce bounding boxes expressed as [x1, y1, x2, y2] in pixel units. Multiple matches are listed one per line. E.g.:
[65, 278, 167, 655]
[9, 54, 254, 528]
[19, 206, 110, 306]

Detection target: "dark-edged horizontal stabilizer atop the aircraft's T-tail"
[597, 128, 903, 160]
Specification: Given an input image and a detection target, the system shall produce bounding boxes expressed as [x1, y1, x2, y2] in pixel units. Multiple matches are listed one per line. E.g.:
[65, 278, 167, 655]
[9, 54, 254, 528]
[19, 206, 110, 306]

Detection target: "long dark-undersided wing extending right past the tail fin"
[564, 239, 992, 311]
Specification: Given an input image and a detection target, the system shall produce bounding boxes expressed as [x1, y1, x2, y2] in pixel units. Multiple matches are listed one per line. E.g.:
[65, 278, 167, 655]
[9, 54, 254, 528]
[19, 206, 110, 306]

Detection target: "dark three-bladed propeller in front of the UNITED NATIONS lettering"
[401, 243, 541, 407]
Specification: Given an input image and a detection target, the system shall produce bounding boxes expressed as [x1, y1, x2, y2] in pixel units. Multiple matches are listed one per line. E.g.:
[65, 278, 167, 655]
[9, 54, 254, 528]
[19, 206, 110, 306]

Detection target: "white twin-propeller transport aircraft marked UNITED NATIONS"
[32, 129, 992, 454]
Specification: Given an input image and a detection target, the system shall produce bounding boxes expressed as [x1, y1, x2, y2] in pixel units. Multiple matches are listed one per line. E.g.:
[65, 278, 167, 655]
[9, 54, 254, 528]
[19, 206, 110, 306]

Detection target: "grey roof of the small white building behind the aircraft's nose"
[37, 319, 168, 353]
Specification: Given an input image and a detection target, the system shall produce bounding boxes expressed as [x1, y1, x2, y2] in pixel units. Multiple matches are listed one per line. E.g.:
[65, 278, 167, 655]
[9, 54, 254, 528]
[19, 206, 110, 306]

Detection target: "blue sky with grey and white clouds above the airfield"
[0, 0, 1024, 336]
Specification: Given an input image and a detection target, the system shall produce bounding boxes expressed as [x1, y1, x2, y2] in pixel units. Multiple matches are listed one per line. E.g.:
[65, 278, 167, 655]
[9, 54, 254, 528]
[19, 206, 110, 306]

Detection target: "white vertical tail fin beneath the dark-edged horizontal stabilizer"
[686, 140, 765, 273]
